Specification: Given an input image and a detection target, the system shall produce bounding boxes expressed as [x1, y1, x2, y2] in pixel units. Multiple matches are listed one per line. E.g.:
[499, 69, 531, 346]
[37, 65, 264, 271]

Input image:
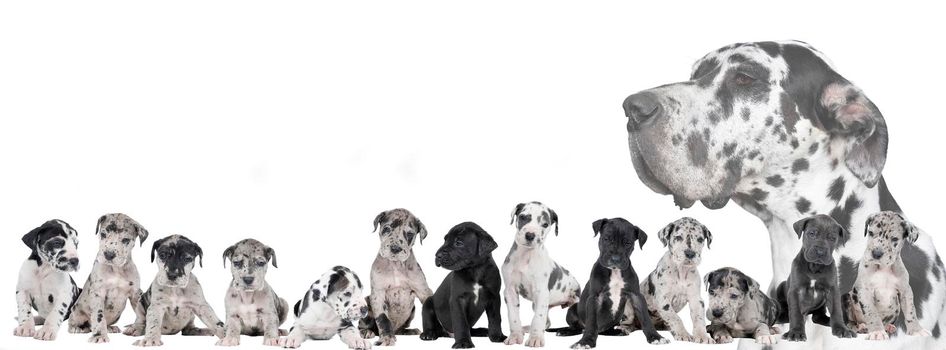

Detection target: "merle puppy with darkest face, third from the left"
[134, 235, 225, 346]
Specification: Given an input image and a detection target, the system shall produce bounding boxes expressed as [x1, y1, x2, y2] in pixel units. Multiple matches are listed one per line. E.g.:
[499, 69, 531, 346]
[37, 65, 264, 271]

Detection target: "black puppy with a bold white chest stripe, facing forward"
[549, 218, 669, 349]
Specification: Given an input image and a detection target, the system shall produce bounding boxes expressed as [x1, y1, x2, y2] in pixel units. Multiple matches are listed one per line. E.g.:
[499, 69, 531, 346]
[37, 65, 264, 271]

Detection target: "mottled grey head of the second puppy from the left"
[95, 213, 148, 266]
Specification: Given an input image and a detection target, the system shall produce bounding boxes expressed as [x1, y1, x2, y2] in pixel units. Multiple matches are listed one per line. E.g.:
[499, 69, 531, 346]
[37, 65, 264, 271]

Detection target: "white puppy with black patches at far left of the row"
[13, 219, 81, 340]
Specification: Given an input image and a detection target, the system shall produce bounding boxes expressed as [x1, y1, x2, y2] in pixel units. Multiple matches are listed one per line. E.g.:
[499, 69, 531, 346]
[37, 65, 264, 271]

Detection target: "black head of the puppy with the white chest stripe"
[591, 218, 647, 270]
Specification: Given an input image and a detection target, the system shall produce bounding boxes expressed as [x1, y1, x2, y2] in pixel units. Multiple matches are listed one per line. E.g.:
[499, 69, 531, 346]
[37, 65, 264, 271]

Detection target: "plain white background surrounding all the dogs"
[0, 1, 946, 349]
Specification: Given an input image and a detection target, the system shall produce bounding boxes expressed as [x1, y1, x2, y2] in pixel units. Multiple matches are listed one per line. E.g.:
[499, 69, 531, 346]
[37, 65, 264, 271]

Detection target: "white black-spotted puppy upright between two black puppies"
[502, 202, 581, 347]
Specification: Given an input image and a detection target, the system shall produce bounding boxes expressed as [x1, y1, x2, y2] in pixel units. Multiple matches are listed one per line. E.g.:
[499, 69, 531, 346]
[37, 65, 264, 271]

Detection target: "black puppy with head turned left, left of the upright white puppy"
[420, 222, 506, 349]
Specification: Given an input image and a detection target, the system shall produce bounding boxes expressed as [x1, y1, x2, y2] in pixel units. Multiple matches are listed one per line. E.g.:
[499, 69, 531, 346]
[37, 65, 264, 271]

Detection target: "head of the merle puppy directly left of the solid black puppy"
[374, 208, 427, 262]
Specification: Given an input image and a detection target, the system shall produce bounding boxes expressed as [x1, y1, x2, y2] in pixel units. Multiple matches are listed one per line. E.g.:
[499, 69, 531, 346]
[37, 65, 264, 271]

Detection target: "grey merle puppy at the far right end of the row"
[849, 211, 930, 340]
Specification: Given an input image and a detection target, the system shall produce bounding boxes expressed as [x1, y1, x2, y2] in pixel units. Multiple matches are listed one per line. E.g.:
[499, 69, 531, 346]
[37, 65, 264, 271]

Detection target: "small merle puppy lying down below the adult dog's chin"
[703, 267, 779, 345]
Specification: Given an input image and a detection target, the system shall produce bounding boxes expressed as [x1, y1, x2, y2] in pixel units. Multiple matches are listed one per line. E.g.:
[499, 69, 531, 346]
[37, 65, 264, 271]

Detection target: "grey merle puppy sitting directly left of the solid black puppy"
[359, 209, 434, 346]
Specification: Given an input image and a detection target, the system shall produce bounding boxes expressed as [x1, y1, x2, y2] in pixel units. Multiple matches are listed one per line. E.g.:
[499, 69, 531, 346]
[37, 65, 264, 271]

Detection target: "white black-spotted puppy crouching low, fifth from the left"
[279, 266, 371, 350]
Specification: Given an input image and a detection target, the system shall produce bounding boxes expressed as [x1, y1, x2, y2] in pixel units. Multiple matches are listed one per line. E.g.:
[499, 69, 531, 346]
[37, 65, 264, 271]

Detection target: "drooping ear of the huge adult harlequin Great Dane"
[819, 80, 887, 188]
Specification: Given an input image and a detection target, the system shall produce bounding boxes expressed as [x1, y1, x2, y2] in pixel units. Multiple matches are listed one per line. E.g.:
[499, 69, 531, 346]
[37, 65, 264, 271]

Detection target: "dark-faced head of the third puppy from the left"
[151, 235, 204, 288]
